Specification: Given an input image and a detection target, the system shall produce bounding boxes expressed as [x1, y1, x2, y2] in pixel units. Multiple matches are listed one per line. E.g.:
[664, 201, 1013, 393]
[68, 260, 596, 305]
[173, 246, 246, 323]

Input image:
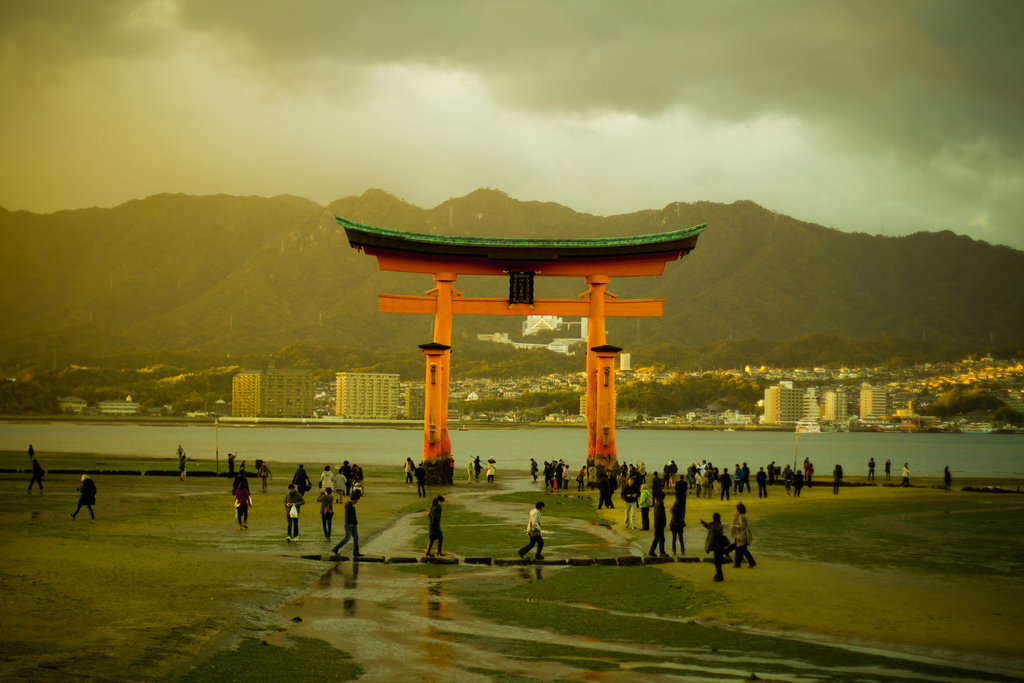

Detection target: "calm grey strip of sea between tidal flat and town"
[0, 422, 1024, 480]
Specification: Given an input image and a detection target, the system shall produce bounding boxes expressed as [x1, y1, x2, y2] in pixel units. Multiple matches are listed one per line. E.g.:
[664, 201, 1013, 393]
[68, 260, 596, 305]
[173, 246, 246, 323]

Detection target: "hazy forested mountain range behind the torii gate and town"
[0, 189, 1024, 366]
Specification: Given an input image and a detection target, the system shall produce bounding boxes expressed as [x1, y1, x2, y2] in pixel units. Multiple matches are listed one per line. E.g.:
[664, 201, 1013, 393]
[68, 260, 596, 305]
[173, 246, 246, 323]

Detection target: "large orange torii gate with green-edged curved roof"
[335, 216, 708, 483]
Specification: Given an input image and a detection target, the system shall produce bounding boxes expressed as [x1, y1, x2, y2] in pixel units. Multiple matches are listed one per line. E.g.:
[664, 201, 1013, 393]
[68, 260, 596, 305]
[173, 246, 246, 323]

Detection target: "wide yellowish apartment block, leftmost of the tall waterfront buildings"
[231, 364, 313, 418]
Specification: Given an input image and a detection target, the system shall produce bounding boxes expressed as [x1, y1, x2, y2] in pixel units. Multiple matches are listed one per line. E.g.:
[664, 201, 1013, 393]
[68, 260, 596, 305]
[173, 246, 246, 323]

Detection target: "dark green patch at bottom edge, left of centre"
[180, 636, 362, 683]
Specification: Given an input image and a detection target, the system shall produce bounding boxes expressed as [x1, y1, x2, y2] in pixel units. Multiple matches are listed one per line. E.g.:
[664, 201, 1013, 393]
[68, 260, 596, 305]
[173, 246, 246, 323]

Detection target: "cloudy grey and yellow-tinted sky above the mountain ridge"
[0, 0, 1024, 249]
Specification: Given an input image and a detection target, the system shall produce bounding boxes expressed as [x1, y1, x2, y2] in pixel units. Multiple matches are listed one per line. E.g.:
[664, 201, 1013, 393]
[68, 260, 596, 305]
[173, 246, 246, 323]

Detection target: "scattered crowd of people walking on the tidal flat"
[19, 445, 952, 582]
